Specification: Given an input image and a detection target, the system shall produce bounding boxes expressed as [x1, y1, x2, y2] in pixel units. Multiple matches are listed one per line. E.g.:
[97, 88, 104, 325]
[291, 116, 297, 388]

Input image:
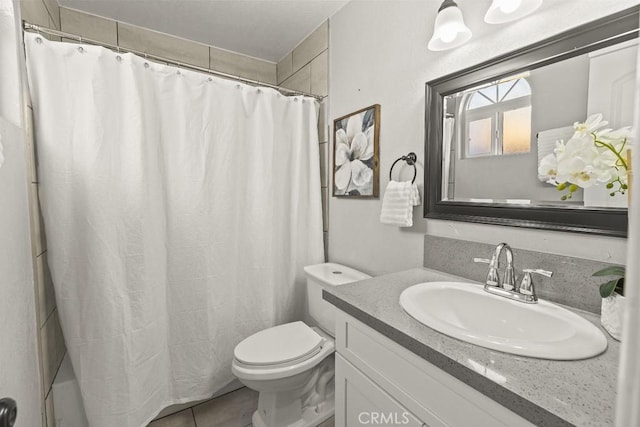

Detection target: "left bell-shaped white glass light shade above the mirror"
[428, 0, 471, 50]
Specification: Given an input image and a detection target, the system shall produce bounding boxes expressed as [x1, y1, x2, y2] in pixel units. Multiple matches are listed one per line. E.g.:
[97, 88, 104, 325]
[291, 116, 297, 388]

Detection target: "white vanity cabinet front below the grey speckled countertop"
[335, 311, 533, 427]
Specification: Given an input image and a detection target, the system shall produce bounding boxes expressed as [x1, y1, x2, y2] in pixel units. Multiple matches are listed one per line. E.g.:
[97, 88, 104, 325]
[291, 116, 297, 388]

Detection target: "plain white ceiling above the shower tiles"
[58, 0, 348, 62]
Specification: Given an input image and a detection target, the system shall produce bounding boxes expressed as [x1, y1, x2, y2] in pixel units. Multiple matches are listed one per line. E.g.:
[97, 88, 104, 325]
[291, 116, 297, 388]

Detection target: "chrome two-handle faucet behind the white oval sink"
[473, 243, 553, 304]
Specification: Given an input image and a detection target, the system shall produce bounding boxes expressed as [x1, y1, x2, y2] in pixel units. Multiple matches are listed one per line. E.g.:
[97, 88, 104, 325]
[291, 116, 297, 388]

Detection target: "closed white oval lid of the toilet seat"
[233, 322, 323, 366]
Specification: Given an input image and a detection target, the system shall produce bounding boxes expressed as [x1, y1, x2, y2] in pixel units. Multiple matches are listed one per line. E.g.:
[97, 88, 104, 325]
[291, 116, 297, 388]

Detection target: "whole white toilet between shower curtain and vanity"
[231, 263, 371, 427]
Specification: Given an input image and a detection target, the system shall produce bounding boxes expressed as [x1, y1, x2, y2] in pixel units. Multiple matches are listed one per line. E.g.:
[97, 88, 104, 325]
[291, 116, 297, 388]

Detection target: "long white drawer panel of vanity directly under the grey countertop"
[336, 312, 536, 427]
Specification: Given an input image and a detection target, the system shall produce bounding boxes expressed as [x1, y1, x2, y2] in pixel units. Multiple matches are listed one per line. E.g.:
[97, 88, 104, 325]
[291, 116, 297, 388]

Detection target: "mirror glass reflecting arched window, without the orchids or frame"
[442, 40, 637, 208]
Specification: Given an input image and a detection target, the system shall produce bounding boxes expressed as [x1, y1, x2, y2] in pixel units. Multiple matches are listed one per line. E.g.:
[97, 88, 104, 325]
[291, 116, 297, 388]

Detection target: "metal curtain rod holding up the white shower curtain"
[22, 21, 324, 101]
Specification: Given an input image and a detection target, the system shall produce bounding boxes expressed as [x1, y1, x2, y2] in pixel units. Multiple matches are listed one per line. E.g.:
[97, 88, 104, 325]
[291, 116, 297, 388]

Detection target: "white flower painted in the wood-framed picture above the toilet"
[335, 114, 373, 191]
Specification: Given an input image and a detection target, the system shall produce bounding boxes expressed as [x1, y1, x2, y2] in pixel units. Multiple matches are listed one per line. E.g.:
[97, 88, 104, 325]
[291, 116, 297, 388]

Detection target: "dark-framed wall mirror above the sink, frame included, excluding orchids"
[425, 7, 639, 237]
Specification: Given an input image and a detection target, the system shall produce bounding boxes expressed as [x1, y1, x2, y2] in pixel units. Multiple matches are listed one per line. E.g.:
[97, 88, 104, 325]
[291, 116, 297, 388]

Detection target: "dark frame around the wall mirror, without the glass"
[424, 7, 640, 237]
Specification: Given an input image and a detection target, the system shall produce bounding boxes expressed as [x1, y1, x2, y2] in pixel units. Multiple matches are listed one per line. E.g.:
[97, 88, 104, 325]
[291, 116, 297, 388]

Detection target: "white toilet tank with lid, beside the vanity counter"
[304, 262, 371, 337]
